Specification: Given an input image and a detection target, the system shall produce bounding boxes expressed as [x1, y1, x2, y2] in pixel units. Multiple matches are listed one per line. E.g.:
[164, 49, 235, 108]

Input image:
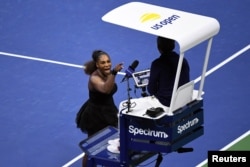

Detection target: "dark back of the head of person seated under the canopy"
[157, 37, 175, 53]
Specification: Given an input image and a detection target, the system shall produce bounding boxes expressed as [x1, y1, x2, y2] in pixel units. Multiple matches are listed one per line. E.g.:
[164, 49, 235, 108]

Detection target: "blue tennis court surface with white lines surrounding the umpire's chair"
[0, 0, 250, 167]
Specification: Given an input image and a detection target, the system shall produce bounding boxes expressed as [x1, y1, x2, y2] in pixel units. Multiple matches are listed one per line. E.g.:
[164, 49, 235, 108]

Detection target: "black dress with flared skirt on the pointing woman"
[77, 84, 118, 136]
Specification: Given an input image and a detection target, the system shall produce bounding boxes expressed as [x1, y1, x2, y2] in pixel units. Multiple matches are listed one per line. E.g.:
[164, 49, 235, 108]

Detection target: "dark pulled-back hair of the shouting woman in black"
[84, 50, 109, 75]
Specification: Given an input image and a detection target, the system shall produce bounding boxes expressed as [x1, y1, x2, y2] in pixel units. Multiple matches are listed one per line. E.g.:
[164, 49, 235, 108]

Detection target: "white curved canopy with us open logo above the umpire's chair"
[102, 2, 220, 52]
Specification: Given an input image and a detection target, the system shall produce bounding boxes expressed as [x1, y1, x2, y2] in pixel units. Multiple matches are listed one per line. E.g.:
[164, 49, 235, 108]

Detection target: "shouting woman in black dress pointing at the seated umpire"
[76, 50, 123, 167]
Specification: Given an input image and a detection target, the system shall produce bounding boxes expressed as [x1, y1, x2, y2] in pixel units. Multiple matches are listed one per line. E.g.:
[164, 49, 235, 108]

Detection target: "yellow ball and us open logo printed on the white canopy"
[140, 13, 180, 30]
